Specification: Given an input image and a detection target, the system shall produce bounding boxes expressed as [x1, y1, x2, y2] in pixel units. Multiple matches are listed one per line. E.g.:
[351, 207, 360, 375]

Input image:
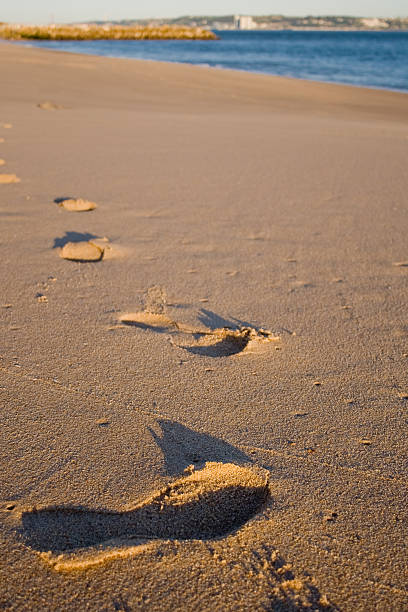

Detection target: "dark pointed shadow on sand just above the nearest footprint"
[149, 419, 252, 476]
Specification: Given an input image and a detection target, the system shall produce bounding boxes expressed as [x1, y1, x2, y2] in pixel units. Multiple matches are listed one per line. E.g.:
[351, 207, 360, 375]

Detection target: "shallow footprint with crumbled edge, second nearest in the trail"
[119, 305, 280, 357]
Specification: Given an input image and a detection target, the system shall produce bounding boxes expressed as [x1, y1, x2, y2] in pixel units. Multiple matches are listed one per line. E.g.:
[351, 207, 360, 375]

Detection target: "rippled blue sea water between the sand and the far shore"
[19, 30, 408, 92]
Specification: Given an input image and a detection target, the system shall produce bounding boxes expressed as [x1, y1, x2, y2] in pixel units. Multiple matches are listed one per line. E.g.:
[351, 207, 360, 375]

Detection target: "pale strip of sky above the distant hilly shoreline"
[0, 0, 408, 23]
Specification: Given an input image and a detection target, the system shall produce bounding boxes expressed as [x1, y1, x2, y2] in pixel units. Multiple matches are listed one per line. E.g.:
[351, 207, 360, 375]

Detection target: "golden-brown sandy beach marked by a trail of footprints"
[0, 43, 408, 612]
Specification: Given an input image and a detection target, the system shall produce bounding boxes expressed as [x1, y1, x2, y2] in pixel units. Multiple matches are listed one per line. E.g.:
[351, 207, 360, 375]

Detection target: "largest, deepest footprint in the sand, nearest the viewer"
[21, 462, 270, 571]
